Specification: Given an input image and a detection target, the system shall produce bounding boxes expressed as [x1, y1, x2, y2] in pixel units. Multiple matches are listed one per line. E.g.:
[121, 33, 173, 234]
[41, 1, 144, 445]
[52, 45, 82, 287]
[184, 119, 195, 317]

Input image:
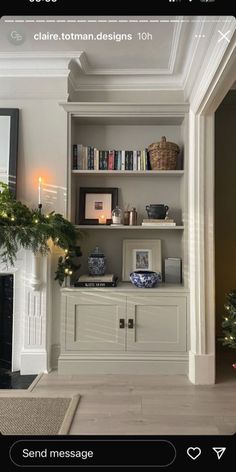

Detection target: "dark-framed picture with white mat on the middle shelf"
[78, 187, 118, 225]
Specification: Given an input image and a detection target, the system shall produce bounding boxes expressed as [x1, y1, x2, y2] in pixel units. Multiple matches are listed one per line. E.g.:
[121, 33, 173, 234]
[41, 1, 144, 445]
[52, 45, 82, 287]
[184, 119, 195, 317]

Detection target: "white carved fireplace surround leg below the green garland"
[0, 250, 51, 375]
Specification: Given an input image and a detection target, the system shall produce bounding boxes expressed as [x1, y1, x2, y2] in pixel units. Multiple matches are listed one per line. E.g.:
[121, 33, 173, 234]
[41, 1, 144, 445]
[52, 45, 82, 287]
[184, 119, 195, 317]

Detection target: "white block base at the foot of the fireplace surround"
[20, 351, 48, 375]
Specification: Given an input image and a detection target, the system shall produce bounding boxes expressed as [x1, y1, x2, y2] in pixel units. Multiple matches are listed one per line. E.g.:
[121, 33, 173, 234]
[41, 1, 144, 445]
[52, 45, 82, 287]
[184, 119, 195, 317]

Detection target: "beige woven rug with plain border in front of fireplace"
[0, 395, 80, 436]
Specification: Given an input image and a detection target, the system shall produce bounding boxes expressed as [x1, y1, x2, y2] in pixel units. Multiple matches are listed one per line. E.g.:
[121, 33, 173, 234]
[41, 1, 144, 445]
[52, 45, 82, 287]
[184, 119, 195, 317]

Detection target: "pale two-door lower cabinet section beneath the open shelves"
[59, 284, 188, 374]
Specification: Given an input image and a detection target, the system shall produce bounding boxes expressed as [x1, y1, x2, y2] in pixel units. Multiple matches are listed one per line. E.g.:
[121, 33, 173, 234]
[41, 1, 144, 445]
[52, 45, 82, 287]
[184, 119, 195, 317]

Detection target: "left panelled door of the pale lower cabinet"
[65, 291, 126, 351]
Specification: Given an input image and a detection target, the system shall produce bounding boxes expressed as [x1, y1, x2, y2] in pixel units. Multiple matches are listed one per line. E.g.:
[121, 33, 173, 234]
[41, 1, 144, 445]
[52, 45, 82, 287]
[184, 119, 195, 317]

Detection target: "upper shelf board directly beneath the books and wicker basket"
[72, 170, 184, 177]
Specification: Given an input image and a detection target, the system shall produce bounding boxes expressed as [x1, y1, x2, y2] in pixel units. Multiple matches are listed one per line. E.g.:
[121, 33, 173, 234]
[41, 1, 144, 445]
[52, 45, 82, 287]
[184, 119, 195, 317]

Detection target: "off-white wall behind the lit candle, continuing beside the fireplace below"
[0, 77, 67, 364]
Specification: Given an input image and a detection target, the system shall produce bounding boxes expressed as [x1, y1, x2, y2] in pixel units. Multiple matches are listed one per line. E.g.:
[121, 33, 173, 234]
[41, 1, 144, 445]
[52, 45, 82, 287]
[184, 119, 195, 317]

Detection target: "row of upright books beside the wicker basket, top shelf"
[72, 144, 150, 170]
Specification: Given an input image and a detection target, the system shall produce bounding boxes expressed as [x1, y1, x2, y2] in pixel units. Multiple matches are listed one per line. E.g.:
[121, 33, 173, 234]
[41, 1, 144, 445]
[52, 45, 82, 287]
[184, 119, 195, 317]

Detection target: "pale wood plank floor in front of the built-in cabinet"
[34, 366, 236, 435]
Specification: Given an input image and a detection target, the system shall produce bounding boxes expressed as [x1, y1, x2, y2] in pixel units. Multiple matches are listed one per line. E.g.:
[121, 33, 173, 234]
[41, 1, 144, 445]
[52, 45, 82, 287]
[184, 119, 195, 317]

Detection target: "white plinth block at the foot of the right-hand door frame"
[189, 351, 215, 385]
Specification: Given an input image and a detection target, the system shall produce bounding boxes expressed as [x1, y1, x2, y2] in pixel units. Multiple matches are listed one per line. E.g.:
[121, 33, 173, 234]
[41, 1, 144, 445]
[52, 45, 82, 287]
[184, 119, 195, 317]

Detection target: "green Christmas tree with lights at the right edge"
[219, 290, 236, 369]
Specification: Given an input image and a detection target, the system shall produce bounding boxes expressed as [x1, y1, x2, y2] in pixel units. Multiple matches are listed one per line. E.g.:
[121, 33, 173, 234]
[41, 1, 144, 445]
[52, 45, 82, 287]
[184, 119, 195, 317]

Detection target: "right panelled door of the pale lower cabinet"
[127, 295, 187, 352]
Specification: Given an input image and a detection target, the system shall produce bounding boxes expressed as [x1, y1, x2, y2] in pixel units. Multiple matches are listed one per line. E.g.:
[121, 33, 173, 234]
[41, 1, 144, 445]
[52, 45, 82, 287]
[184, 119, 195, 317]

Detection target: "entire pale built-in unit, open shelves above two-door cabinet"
[59, 103, 188, 374]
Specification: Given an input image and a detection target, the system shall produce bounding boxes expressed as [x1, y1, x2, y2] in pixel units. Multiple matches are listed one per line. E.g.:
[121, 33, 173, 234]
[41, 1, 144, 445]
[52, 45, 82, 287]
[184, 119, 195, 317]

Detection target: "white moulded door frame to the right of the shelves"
[188, 33, 236, 384]
